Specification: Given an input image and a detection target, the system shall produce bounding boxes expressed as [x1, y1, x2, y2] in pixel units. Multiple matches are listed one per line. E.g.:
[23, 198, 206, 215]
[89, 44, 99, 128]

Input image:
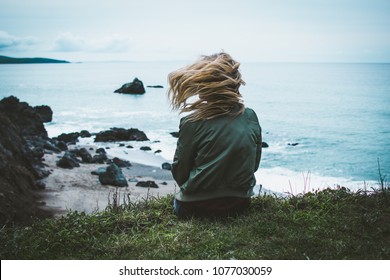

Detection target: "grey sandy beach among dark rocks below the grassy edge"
[42, 145, 178, 215]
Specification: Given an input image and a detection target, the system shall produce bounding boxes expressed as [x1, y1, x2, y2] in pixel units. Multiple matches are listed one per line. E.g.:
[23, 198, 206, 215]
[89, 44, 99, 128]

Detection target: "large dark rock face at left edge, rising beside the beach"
[0, 96, 51, 225]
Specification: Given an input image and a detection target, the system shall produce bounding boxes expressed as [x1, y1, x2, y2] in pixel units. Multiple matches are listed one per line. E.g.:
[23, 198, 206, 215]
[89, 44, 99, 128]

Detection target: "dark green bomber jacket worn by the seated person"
[172, 108, 262, 201]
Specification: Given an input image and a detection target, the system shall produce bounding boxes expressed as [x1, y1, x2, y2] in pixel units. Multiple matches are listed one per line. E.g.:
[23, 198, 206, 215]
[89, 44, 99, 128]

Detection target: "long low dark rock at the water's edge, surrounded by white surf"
[95, 127, 149, 142]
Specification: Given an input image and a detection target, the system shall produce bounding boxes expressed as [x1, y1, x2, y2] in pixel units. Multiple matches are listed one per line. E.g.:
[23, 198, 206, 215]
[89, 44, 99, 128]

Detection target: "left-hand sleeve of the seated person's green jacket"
[172, 119, 195, 186]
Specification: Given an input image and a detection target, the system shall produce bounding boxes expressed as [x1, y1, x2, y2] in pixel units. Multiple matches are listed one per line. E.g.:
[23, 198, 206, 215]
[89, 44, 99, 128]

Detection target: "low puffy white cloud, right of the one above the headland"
[53, 32, 133, 53]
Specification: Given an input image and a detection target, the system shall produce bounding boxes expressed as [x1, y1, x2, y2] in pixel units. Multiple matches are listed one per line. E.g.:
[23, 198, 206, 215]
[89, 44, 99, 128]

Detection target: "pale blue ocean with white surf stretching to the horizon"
[0, 61, 390, 194]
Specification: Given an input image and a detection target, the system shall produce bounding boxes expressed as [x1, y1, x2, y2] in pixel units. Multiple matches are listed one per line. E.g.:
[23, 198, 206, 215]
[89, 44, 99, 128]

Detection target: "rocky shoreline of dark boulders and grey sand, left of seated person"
[0, 96, 175, 225]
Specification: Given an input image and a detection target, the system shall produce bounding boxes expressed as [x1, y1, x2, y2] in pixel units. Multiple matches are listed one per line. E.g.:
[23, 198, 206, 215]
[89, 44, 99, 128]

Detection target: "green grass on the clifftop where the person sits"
[0, 188, 390, 260]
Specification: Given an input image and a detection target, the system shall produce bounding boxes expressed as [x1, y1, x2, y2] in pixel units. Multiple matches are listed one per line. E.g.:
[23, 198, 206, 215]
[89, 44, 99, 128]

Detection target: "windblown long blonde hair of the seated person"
[168, 52, 245, 121]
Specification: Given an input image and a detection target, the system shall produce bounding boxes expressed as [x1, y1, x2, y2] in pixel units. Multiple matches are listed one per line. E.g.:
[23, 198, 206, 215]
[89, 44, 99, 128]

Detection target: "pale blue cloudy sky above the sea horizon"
[0, 0, 390, 62]
